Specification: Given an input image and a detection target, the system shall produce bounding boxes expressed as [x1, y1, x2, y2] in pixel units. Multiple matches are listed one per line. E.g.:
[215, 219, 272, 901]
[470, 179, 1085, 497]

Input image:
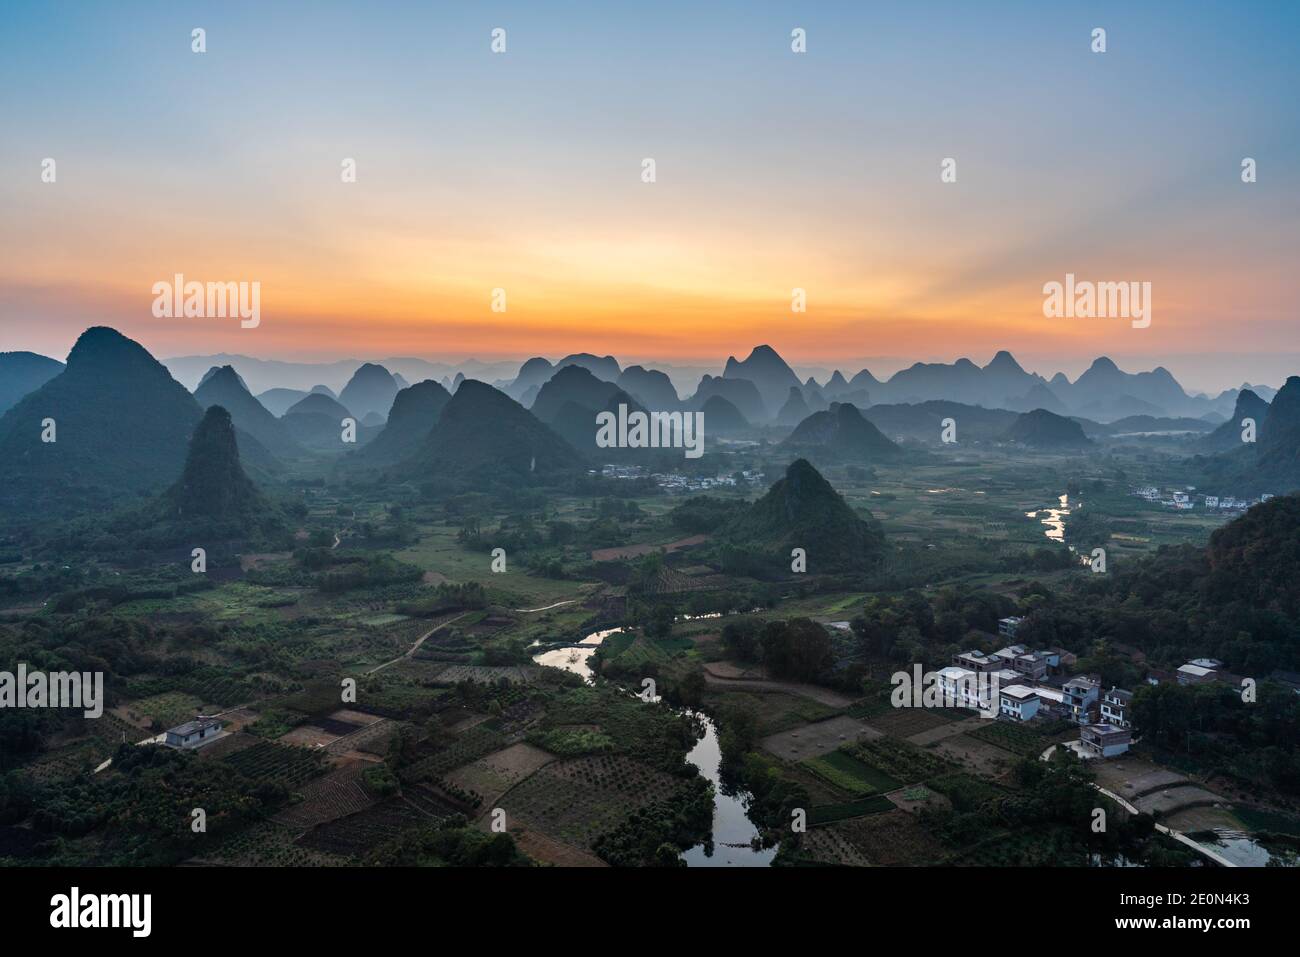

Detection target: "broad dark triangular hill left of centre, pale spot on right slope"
[403, 378, 594, 485]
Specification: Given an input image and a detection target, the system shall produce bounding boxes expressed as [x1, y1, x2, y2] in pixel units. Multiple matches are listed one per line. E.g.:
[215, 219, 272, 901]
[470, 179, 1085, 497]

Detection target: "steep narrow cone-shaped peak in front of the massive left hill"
[157, 406, 285, 545]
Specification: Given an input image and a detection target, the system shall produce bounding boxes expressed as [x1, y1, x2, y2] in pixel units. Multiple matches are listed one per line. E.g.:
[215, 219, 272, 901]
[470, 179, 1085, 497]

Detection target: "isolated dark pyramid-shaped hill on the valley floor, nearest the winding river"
[718, 459, 884, 575]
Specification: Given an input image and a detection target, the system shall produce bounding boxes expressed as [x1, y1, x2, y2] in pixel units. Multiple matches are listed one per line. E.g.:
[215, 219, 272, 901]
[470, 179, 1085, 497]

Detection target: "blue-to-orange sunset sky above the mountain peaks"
[0, 0, 1300, 390]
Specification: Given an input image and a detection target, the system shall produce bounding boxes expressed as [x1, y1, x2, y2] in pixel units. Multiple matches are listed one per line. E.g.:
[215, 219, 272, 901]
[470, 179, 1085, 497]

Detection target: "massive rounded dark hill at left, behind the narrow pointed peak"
[0, 326, 203, 511]
